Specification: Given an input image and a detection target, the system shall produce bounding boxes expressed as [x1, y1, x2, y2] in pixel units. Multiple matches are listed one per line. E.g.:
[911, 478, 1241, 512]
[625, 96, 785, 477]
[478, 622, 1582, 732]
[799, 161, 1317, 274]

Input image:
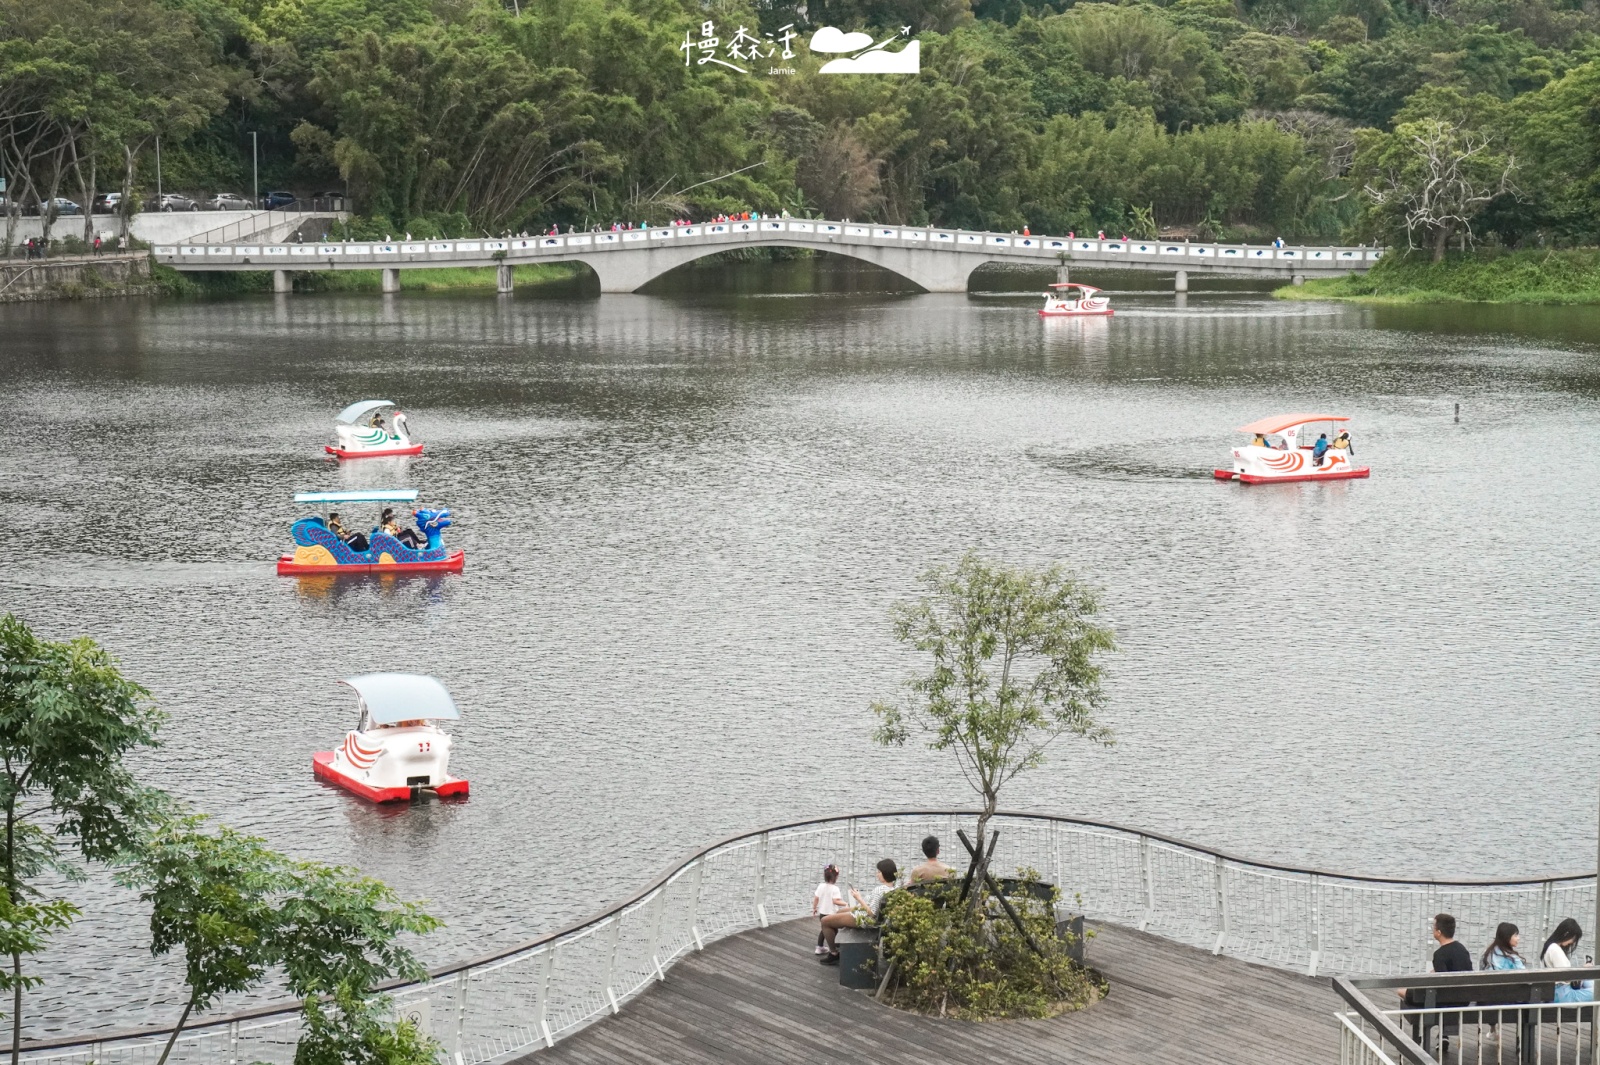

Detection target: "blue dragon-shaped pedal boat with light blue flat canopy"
[278, 488, 467, 577]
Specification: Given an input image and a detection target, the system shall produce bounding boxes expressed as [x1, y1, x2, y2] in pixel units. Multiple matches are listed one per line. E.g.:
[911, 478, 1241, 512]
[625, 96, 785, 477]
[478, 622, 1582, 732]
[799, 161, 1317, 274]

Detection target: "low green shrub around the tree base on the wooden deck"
[883, 870, 1106, 1020]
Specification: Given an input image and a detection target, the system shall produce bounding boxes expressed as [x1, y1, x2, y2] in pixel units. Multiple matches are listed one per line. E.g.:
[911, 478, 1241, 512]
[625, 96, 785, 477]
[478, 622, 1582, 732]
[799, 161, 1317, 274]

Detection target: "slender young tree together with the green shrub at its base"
[872, 553, 1117, 1017]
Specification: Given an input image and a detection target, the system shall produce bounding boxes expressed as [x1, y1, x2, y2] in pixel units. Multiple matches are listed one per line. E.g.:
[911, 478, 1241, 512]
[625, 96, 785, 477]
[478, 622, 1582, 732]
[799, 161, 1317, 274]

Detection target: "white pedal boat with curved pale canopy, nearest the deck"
[310, 673, 467, 803]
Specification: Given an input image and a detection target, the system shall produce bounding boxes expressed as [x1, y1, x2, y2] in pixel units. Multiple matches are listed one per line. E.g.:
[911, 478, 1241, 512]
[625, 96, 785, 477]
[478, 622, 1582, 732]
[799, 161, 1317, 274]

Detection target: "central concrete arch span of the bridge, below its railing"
[560, 235, 997, 293]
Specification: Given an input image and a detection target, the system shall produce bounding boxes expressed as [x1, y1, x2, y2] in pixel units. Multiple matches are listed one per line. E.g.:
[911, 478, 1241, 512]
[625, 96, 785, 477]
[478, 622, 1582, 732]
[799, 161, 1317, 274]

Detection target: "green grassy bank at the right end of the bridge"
[1274, 248, 1600, 304]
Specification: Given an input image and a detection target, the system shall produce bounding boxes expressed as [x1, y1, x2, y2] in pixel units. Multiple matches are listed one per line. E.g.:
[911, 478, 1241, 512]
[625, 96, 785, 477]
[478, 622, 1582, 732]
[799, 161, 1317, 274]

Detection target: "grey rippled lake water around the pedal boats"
[0, 264, 1600, 1036]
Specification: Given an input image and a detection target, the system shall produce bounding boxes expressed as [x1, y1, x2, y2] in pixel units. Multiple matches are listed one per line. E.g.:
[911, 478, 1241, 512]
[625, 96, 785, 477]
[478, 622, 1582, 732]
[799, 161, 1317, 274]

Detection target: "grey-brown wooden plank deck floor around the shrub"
[518, 919, 1339, 1065]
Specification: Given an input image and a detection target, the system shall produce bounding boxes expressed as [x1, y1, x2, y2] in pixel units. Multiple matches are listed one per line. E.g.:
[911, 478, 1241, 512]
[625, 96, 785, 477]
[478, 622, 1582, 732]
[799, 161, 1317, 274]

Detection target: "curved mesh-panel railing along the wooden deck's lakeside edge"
[24, 811, 1595, 1065]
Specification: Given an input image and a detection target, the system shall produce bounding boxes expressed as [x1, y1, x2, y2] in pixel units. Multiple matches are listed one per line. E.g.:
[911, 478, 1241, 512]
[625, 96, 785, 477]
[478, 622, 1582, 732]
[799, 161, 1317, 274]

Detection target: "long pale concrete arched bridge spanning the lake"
[154, 219, 1382, 293]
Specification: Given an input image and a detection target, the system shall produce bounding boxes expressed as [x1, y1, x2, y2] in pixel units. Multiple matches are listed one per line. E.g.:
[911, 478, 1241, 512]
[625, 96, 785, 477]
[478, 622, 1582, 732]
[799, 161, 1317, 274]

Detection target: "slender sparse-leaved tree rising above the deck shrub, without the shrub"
[872, 552, 1117, 883]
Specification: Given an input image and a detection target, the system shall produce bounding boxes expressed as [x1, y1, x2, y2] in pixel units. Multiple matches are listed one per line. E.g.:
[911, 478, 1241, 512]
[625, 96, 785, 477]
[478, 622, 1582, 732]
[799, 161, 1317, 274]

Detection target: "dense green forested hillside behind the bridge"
[0, 0, 1600, 251]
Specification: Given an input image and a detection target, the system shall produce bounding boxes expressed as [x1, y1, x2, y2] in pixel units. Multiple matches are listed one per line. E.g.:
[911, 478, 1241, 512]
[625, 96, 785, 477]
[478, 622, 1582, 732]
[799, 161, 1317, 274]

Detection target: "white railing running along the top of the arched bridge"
[154, 219, 1384, 272]
